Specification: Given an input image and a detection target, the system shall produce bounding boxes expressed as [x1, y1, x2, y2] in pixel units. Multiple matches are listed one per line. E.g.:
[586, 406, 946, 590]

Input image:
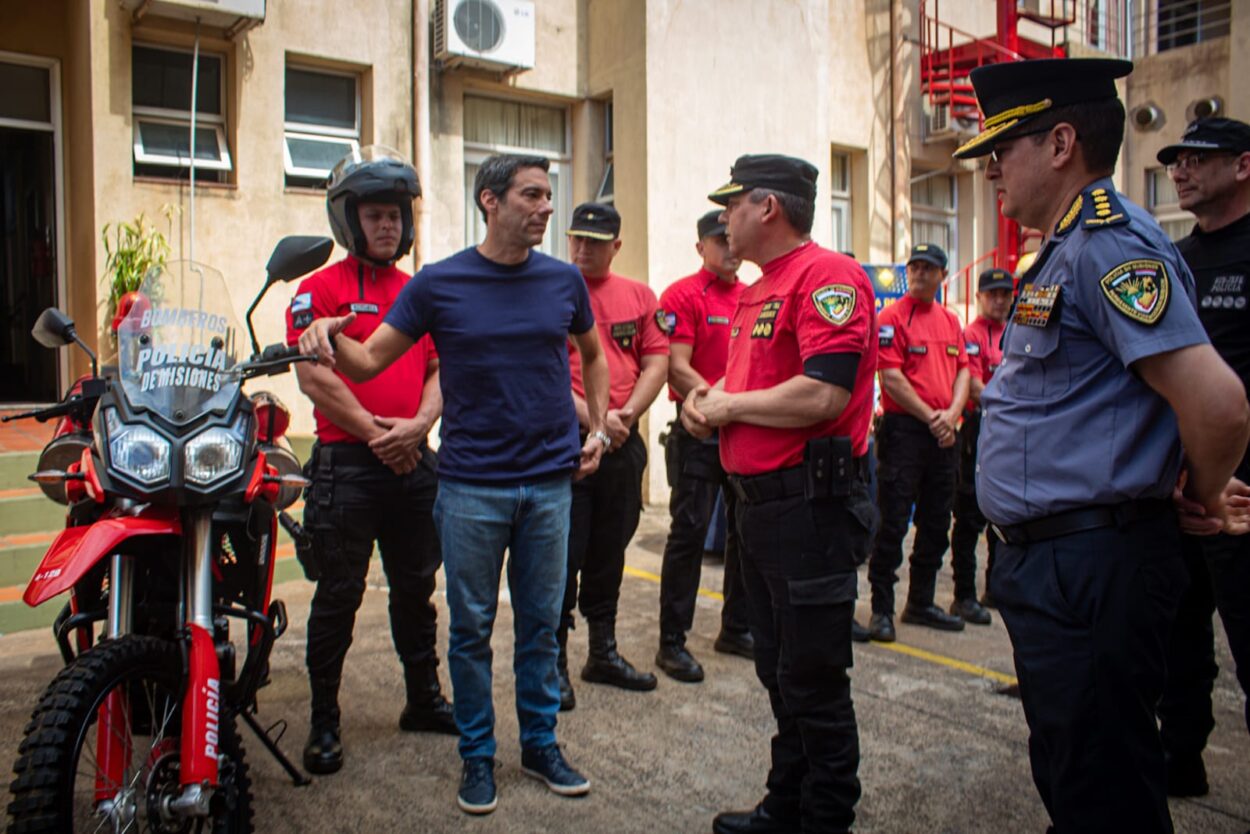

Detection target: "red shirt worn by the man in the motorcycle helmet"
[286, 255, 438, 443]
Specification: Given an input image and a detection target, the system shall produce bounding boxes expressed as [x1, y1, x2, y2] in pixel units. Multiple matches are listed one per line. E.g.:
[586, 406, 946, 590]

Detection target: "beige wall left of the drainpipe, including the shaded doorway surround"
[0, 0, 414, 433]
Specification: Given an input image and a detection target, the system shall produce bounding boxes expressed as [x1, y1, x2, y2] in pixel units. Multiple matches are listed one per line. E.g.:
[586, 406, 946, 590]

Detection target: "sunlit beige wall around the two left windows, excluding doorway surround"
[91, 0, 413, 433]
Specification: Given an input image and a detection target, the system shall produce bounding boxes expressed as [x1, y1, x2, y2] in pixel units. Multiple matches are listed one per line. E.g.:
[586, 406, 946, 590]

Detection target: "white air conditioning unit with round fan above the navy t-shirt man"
[434, 0, 534, 73]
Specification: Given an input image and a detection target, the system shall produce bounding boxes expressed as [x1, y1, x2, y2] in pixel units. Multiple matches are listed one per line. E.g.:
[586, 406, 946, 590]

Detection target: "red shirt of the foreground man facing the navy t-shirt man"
[720, 241, 878, 475]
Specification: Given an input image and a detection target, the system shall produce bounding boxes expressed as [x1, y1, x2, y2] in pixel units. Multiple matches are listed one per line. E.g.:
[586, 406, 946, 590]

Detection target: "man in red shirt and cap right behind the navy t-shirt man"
[556, 203, 669, 710]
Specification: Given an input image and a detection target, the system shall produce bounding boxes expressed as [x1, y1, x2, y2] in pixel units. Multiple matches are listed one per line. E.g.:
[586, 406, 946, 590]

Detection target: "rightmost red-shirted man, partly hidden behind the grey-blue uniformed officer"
[950, 269, 1015, 625]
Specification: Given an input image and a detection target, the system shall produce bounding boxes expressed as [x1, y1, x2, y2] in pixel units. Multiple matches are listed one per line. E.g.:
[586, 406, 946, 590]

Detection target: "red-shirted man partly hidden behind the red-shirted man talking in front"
[655, 209, 754, 683]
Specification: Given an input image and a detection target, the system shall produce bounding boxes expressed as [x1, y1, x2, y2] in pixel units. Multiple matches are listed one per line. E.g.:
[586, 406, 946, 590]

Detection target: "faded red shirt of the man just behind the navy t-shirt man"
[569, 273, 669, 416]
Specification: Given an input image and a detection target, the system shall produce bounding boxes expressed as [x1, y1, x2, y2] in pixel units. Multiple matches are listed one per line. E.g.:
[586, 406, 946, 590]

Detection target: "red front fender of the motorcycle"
[21, 508, 183, 608]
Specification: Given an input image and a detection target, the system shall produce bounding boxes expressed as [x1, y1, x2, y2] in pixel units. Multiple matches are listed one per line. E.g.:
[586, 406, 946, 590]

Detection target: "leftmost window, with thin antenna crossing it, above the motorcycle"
[130, 44, 231, 181]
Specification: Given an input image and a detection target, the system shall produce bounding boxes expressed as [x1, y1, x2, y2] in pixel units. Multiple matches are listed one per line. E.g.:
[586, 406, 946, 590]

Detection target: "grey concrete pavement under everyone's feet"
[0, 509, 1250, 834]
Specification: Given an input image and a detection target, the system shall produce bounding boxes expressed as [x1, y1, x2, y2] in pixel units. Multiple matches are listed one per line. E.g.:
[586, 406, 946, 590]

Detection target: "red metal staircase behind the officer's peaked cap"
[920, 0, 1076, 271]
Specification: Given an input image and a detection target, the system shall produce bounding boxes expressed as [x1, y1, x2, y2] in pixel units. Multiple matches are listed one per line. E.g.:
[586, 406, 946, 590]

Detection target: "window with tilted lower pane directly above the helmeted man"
[283, 65, 360, 188]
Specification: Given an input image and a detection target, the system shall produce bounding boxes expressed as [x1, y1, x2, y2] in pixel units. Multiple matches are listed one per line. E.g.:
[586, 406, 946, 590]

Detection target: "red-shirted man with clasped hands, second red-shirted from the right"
[868, 244, 975, 643]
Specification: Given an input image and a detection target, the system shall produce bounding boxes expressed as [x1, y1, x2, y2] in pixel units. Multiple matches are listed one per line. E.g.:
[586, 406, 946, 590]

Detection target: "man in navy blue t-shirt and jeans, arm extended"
[300, 155, 611, 814]
